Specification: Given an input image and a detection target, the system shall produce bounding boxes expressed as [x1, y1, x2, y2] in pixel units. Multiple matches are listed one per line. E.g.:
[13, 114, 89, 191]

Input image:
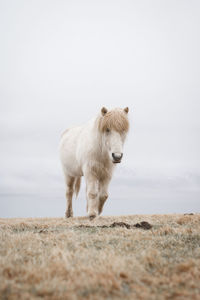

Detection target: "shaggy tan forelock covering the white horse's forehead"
[98, 109, 129, 133]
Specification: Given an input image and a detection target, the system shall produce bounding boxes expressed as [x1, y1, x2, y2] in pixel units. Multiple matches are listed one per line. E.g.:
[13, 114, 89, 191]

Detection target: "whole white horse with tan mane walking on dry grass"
[59, 107, 129, 219]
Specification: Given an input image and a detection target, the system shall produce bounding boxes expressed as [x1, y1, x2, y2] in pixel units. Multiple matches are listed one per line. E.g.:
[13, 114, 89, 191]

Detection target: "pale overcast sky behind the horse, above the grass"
[0, 0, 200, 217]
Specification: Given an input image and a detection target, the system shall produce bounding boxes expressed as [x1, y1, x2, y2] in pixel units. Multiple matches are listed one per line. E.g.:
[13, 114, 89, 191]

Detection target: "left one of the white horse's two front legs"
[85, 175, 99, 219]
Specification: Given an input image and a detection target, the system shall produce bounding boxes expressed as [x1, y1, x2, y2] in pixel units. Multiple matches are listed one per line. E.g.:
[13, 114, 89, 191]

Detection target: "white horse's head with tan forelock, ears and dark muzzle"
[99, 107, 129, 163]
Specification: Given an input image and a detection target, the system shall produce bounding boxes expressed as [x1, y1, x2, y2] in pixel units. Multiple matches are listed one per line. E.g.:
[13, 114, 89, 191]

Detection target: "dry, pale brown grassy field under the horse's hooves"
[0, 214, 200, 300]
